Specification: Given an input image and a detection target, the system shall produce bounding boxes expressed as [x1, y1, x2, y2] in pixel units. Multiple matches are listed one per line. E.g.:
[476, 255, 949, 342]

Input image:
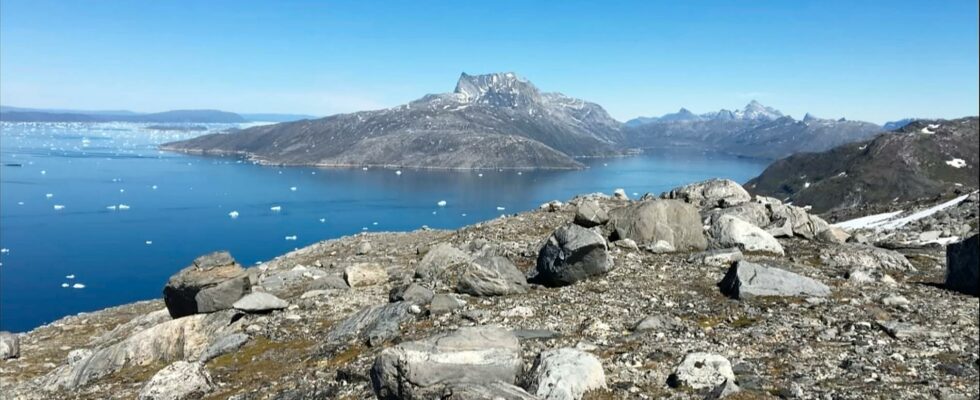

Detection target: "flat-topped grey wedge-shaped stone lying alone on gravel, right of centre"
[718, 260, 830, 299]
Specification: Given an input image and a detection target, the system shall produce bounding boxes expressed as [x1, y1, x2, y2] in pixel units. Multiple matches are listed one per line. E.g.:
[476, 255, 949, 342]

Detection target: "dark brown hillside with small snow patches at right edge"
[745, 117, 980, 212]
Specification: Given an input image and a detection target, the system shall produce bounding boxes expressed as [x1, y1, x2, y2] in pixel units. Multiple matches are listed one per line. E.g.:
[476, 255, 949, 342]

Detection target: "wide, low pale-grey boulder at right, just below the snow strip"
[820, 243, 915, 271]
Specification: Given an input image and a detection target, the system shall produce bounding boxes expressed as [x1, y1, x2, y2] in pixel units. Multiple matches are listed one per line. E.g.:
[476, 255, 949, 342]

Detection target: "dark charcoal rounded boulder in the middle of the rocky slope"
[528, 224, 613, 286]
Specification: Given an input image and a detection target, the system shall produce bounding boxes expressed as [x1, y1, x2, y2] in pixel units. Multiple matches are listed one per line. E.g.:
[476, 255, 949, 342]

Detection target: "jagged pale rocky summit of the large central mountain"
[454, 72, 541, 108]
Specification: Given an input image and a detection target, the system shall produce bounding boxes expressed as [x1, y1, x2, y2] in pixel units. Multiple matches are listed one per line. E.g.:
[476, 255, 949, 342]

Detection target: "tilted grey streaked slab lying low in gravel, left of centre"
[327, 301, 415, 346]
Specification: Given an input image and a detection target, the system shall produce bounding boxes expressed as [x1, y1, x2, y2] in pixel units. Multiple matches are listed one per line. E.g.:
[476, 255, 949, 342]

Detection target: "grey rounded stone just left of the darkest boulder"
[456, 256, 527, 296]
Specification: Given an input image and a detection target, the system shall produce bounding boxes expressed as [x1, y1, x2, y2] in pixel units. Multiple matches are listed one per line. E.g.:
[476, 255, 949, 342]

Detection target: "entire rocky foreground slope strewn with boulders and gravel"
[0, 180, 980, 399]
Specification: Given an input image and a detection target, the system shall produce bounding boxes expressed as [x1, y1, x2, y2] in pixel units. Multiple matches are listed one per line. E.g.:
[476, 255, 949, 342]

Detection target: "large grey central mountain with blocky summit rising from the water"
[162, 73, 623, 169]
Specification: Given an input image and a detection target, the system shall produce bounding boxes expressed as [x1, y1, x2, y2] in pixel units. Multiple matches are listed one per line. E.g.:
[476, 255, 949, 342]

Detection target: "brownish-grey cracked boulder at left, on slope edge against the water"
[163, 251, 252, 318]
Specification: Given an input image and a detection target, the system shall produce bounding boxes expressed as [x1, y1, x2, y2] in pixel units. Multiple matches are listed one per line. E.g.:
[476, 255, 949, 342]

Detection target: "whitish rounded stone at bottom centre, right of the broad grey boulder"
[527, 348, 606, 400]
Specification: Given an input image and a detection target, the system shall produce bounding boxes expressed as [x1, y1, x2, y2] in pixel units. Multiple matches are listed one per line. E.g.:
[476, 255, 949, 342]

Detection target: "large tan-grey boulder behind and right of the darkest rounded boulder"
[608, 200, 708, 251]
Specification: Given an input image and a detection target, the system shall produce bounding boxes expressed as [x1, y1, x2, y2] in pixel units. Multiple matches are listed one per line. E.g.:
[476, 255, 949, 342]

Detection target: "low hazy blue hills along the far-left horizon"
[0, 106, 316, 123]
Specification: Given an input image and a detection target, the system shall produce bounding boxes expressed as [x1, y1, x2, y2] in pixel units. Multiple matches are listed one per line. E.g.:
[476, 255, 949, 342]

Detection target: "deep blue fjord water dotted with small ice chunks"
[0, 123, 765, 331]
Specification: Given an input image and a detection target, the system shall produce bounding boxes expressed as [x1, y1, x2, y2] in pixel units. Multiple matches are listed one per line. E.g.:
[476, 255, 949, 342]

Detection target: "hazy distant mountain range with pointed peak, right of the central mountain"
[623, 100, 882, 159]
